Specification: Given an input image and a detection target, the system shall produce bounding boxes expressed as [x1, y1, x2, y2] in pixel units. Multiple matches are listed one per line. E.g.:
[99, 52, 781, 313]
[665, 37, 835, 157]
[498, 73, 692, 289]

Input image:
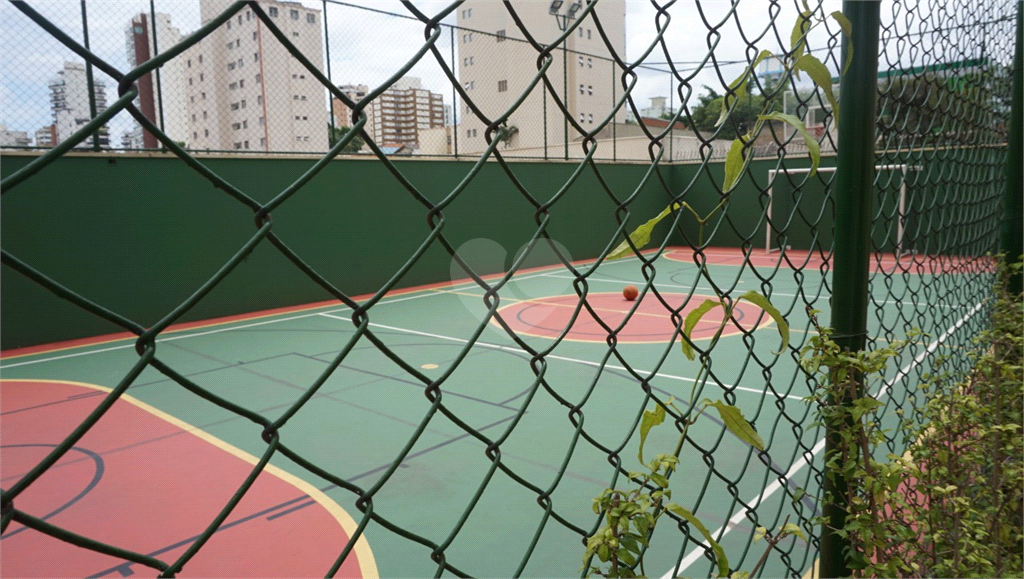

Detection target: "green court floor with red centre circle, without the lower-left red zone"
[0, 245, 979, 577]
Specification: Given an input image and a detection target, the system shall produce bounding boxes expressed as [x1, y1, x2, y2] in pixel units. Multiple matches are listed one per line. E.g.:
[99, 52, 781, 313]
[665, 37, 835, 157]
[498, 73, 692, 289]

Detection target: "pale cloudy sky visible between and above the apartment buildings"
[0, 0, 974, 144]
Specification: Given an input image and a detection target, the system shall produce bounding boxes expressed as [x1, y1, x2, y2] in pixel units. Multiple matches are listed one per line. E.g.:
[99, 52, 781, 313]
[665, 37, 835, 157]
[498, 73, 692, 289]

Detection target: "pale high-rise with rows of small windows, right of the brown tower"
[181, 0, 329, 153]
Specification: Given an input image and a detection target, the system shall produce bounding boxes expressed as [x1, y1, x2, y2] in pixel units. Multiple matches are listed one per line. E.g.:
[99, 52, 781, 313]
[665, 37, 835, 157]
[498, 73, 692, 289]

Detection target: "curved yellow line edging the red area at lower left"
[0, 378, 380, 579]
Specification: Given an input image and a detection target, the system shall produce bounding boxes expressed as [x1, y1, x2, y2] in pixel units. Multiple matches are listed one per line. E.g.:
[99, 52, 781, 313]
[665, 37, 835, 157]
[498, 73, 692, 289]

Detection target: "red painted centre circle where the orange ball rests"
[498, 292, 771, 343]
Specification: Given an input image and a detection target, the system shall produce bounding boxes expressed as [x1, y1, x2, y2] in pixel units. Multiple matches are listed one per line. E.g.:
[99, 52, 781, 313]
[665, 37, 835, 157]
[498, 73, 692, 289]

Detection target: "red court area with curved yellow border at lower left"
[0, 380, 377, 577]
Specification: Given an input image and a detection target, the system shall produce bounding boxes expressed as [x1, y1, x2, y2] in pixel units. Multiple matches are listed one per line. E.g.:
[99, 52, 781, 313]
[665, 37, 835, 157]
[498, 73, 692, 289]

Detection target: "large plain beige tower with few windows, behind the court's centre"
[456, 0, 626, 155]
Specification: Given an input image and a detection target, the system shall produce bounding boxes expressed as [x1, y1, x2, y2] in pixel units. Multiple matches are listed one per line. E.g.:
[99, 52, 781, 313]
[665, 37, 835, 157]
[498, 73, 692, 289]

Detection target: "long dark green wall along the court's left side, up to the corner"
[0, 154, 669, 349]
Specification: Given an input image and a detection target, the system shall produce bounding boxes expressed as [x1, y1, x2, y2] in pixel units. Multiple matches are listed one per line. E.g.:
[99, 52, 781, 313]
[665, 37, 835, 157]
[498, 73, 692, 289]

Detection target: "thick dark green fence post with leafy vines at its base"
[819, 0, 879, 577]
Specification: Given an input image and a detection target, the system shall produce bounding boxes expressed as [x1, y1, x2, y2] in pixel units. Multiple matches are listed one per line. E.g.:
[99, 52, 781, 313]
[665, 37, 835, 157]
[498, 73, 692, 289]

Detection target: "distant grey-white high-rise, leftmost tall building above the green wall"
[49, 61, 111, 149]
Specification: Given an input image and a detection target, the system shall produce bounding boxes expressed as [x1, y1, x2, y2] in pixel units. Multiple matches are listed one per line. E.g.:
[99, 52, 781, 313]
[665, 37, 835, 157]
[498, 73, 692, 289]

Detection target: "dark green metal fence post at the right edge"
[999, 2, 1024, 295]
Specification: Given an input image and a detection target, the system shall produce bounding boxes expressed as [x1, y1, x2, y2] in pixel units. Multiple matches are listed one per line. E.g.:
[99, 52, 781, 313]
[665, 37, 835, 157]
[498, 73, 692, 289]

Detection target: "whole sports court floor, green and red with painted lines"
[0, 249, 978, 577]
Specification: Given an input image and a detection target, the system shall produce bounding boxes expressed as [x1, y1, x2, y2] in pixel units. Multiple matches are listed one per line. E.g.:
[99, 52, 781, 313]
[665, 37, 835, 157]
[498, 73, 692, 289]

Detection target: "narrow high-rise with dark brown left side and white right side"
[123, 12, 190, 149]
